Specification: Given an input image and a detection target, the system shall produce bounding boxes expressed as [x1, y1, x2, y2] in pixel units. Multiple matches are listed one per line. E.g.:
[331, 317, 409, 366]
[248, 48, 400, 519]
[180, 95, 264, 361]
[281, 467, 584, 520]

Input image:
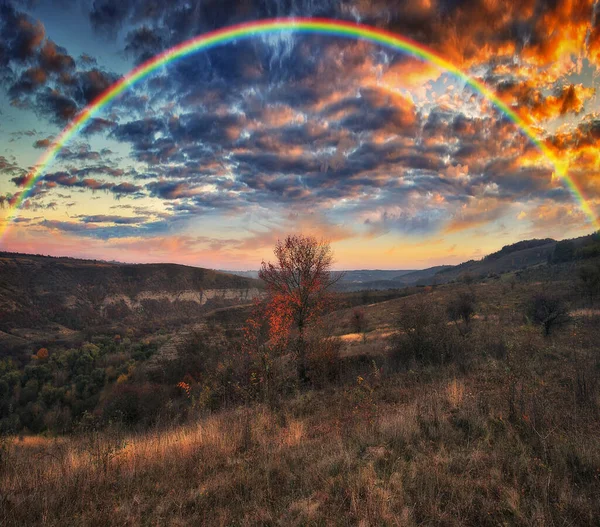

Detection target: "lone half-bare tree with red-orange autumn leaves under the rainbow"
[258, 235, 342, 382]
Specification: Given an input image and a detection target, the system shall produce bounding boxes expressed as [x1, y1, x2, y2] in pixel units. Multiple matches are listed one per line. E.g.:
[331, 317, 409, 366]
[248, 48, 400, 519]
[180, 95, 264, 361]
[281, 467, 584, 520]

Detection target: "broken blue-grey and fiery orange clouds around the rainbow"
[0, 0, 600, 264]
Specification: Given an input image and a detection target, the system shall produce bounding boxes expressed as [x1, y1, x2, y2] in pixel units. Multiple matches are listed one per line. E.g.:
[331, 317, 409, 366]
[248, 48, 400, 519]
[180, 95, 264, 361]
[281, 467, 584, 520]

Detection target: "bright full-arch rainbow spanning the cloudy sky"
[0, 18, 600, 240]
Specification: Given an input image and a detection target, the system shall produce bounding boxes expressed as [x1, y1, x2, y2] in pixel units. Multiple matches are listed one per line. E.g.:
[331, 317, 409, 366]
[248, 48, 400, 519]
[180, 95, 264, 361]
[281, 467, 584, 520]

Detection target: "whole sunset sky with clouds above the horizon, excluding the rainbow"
[0, 0, 600, 270]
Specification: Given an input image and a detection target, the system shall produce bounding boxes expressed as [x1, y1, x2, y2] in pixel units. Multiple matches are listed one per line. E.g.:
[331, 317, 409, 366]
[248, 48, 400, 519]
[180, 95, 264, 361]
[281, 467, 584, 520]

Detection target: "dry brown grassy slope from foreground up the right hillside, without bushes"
[0, 281, 600, 526]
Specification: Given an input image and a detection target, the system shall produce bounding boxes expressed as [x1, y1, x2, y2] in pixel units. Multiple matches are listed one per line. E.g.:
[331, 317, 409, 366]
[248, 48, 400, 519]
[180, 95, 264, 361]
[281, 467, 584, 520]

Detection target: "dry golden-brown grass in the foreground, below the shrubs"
[0, 344, 600, 525]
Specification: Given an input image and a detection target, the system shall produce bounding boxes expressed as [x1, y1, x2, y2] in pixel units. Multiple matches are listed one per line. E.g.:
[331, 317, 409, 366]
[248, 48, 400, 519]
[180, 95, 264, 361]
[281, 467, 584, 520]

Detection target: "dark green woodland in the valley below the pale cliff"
[0, 337, 162, 434]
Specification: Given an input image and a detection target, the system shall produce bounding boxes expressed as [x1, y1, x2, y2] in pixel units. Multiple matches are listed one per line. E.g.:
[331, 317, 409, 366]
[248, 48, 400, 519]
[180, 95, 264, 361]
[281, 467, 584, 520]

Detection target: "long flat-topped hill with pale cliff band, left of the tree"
[0, 253, 261, 334]
